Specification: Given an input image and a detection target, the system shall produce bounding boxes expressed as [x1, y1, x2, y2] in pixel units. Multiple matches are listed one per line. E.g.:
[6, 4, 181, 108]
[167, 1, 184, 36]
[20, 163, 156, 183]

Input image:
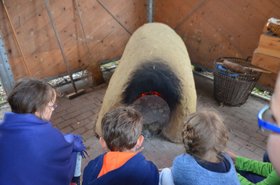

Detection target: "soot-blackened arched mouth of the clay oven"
[122, 59, 182, 137]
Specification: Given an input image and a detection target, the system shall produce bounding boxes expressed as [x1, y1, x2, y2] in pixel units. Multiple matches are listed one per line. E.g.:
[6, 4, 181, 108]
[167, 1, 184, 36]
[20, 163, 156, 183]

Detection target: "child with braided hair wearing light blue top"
[160, 111, 240, 185]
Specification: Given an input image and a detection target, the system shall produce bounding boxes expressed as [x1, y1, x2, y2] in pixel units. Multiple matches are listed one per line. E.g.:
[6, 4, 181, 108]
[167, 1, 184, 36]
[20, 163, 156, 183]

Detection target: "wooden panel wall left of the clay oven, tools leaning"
[0, 0, 146, 83]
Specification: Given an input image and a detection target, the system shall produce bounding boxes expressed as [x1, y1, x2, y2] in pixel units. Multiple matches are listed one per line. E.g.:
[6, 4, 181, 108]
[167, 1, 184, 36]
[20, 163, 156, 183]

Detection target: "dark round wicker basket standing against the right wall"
[214, 57, 261, 106]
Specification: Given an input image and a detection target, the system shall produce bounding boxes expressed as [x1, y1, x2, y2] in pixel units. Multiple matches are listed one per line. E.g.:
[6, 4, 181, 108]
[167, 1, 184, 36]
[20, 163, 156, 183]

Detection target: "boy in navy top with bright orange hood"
[83, 107, 159, 185]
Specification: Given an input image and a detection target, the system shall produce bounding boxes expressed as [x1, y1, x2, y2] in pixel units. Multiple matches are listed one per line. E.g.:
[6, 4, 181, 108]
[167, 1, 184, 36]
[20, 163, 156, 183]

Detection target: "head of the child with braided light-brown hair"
[182, 110, 228, 158]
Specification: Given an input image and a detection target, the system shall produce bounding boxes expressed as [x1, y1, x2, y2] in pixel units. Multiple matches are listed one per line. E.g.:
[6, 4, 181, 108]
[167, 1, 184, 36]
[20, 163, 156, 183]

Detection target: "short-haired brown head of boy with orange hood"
[101, 107, 144, 151]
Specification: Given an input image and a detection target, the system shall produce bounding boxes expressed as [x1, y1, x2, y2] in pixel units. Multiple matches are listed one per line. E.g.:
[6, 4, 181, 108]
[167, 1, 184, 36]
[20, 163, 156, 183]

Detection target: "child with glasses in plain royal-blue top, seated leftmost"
[0, 78, 85, 185]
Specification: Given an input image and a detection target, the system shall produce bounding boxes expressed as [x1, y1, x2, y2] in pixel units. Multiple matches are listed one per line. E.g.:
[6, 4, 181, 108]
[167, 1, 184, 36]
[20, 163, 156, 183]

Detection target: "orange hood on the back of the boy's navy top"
[98, 152, 137, 177]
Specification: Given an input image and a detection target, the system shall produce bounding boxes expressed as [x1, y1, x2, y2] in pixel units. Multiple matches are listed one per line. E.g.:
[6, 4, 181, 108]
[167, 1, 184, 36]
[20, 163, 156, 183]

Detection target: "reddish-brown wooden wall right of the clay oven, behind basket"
[154, 0, 280, 89]
